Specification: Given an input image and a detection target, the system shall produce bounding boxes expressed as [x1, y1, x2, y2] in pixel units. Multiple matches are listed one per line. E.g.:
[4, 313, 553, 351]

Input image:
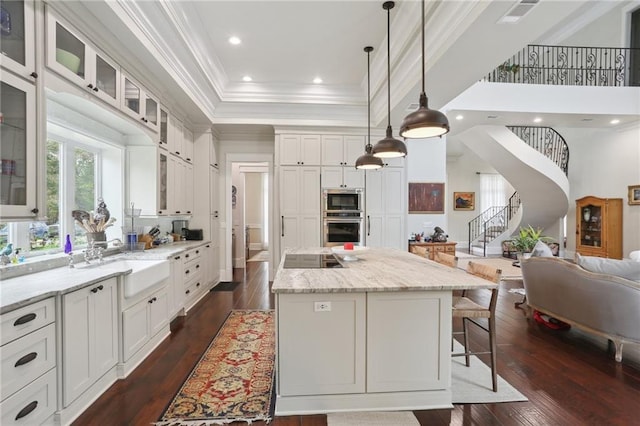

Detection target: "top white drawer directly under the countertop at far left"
[0, 297, 55, 345]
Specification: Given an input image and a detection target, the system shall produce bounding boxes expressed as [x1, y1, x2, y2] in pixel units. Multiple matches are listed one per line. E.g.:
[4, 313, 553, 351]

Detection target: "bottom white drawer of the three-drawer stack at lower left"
[0, 368, 56, 426]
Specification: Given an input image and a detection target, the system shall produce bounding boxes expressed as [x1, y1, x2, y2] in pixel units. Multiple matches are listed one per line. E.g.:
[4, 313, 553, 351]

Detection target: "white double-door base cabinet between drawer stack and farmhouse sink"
[62, 278, 119, 407]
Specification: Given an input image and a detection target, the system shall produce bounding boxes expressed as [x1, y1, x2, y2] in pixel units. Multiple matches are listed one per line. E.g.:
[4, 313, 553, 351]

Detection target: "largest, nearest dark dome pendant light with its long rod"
[400, 0, 449, 139]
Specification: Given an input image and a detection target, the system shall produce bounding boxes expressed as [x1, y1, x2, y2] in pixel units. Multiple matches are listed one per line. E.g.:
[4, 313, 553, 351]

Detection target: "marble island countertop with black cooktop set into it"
[272, 248, 496, 293]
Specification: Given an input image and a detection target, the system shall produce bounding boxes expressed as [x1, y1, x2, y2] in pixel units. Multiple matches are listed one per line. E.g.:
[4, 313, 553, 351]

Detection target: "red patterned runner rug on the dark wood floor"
[156, 310, 275, 426]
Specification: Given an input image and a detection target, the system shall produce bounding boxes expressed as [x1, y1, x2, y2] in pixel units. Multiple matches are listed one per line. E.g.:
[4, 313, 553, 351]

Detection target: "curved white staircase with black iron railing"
[459, 126, 569, 256]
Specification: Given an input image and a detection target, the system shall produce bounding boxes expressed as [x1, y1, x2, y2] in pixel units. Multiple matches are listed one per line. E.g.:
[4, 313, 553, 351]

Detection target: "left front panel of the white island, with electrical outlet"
[276, 293, 364, 396]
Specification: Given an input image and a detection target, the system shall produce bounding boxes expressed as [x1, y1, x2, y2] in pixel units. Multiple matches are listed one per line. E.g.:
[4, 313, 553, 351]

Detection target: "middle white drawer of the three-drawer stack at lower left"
[0, 324, 56, 398]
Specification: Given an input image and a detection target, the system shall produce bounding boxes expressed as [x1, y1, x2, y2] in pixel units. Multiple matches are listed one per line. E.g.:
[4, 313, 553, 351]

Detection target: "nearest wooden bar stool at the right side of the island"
[451, 262, 502, 392]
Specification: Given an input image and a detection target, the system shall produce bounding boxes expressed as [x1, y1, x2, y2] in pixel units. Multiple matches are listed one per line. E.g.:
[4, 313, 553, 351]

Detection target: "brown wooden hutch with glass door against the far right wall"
[576, 196, 622, 259]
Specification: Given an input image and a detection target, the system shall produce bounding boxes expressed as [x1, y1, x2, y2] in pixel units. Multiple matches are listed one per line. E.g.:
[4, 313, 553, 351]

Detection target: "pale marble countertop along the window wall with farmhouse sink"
[0, 241, 208, 314]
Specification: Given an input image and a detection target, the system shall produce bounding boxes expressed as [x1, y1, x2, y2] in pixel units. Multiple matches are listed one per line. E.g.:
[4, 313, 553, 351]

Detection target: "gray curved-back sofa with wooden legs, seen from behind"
[521, 257, 640, 362]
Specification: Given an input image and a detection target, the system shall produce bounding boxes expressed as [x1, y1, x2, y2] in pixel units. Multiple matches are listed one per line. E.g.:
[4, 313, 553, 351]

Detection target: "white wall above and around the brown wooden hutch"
[556, 125, 640, 257]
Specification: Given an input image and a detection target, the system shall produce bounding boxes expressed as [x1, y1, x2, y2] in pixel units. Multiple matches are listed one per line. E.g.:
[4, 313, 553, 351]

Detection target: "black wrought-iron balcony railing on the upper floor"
[483, 45, 640, 86]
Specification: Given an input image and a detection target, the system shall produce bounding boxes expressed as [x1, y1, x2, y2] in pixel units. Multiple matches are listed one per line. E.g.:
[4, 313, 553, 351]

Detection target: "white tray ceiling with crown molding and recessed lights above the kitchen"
[55, 0, 640, 131]
